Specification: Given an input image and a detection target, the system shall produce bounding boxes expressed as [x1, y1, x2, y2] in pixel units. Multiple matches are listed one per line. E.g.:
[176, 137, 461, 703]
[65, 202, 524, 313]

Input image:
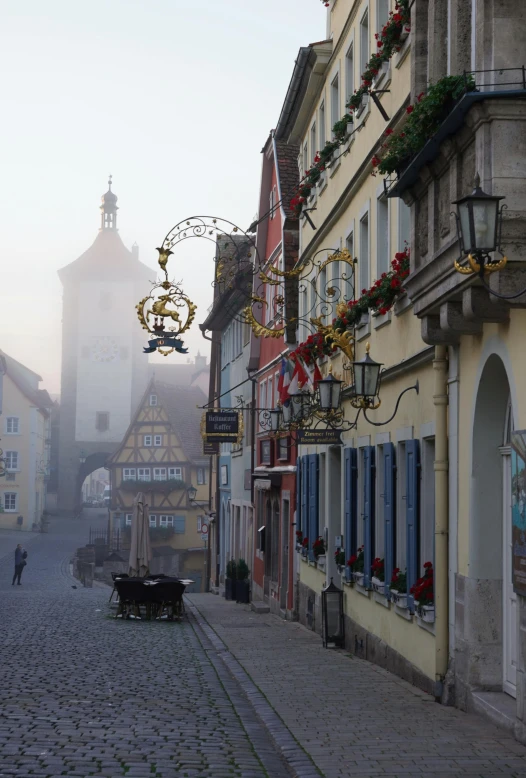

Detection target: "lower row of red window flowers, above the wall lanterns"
[289, 248, 409, 366]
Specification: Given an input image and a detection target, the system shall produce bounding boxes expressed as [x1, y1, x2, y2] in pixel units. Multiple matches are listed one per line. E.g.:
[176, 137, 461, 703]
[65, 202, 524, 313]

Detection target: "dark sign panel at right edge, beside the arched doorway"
[511, 430, 526, 597]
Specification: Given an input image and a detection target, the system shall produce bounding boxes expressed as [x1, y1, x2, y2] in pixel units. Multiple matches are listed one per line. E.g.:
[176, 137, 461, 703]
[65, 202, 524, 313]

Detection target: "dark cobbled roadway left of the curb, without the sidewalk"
[0, 520, 292, 778]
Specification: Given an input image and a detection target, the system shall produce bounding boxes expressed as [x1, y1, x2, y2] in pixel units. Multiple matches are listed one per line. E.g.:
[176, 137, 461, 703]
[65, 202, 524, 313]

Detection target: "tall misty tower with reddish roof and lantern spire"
[57, 176, 156, 515]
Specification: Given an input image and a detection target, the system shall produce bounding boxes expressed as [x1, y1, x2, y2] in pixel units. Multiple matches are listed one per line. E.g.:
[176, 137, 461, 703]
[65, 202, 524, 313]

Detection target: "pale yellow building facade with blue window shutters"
[276, 0, 447, 694]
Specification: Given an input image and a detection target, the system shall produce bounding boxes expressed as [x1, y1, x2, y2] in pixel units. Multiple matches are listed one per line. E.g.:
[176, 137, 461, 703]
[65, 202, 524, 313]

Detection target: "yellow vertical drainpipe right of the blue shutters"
[433, 346, 449, 699]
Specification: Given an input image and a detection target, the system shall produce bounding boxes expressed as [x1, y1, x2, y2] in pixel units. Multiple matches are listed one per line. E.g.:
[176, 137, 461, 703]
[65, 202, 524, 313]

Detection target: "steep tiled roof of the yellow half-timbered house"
[153, 381, 208, 464]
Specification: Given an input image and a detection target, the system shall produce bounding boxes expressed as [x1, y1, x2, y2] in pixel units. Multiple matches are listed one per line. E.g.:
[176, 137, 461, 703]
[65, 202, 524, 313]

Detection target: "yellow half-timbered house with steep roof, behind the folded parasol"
[107, 378, 209, 590]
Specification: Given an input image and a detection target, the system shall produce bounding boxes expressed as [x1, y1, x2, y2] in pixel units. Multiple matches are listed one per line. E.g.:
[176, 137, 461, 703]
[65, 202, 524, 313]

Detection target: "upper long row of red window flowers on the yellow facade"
[290, 0, 411, 216]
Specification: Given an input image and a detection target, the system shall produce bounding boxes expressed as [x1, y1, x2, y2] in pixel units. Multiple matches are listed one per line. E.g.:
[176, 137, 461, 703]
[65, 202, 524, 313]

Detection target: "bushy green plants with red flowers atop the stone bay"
[371, 75, 476, 175]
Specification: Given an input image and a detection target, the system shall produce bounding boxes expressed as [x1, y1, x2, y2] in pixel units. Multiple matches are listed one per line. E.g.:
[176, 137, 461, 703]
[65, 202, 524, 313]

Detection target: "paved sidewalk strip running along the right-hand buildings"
[188, 594, 526, 778]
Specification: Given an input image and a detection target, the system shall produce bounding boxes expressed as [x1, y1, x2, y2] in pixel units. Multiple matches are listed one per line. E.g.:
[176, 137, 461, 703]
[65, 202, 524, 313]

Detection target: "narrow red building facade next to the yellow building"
[250, 132, 299, 618]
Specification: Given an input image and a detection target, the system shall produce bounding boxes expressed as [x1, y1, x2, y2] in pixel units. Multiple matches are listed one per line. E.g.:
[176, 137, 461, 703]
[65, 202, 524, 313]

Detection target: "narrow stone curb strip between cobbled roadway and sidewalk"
[185, 598, 323, 778]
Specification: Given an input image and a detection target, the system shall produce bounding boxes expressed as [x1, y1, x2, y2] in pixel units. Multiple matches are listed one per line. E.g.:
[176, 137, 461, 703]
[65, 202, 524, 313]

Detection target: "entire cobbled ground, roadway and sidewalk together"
[0, 520, 526, 778]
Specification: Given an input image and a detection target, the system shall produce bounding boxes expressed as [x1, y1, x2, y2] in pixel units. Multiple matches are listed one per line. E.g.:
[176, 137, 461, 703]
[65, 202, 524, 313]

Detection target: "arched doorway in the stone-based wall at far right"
[470, 354, 518, 696]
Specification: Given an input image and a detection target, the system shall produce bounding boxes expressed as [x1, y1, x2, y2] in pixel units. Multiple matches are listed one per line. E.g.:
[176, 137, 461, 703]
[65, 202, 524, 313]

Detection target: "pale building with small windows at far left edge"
[0, 351, 53, 530]
